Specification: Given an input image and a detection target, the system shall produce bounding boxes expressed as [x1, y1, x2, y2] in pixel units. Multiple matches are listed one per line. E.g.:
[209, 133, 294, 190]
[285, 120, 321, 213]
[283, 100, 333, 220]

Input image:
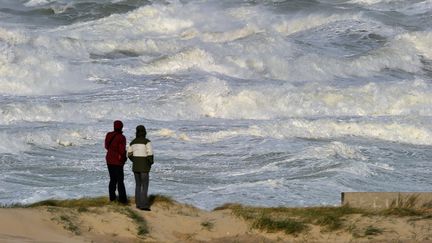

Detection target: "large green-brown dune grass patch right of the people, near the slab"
[214, 200, 432, 237]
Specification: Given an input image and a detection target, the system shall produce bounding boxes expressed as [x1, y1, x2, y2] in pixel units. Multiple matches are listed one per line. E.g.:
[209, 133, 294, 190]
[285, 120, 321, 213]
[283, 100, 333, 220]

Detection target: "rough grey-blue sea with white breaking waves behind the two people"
[0, 0, 432, 209]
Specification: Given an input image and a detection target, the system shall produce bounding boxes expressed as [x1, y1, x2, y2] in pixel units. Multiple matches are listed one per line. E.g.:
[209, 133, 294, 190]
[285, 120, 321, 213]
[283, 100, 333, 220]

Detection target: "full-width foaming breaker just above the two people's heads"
[0, 75, 432, 124]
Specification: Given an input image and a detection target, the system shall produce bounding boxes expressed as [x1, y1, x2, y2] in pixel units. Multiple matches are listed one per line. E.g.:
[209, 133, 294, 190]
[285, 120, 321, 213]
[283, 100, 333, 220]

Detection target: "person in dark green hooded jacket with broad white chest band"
[128, 125, 153, 211]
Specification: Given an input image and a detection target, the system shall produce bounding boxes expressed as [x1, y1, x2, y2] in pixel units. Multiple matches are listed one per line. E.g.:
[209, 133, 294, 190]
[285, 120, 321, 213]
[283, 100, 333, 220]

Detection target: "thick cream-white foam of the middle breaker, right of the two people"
[184, 79, 432, 119]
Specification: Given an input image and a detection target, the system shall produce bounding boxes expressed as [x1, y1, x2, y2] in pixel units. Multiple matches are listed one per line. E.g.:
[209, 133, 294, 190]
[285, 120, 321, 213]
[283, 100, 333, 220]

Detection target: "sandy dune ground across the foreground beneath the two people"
[0, 196, 432, 242]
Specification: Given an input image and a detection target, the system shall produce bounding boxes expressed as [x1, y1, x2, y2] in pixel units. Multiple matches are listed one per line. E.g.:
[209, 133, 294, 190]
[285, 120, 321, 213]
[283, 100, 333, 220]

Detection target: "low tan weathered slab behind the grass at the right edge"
[341, 192, 432, 209]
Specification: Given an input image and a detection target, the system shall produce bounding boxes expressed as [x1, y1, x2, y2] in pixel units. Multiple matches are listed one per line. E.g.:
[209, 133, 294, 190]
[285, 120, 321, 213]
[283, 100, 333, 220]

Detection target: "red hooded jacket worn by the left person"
[105, 121, 127, 165]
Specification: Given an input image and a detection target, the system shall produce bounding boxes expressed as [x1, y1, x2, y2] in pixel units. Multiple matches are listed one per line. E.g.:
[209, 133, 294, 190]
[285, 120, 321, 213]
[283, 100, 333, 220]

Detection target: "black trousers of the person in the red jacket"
[108, 165, 127, 203]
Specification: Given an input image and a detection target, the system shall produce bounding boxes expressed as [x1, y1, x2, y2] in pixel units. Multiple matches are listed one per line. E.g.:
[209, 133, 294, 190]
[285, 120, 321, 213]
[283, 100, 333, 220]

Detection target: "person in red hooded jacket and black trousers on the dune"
[105, 120, 128, 204]
